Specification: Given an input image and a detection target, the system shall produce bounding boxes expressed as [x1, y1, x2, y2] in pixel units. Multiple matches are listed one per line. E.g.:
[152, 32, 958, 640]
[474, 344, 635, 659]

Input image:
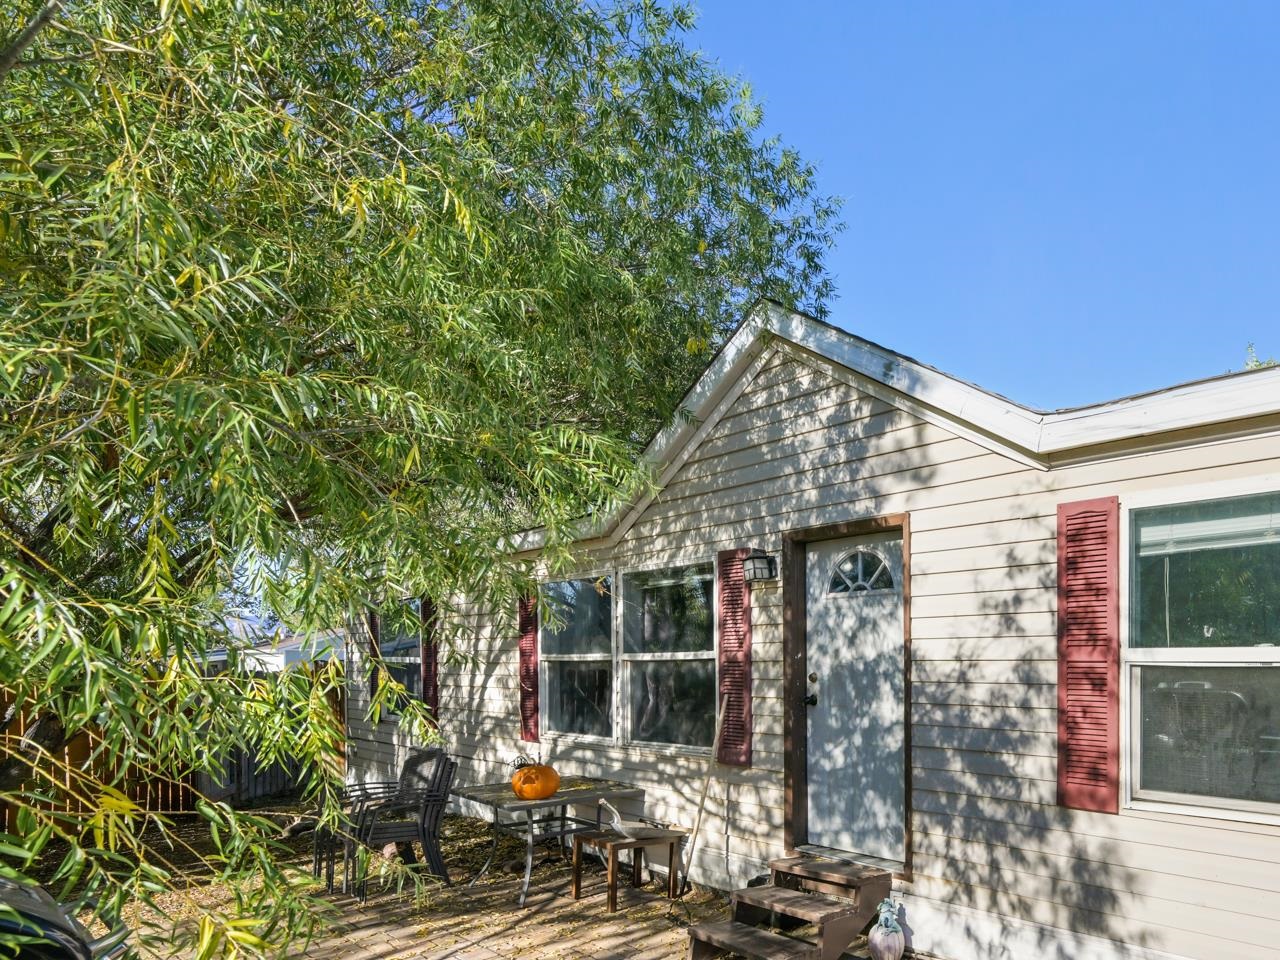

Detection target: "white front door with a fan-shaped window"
[805, 532, 906, 861]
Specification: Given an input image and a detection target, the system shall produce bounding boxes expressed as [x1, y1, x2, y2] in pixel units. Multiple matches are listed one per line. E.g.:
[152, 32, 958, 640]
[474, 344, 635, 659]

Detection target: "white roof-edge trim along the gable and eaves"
[516, 301, 1280, 552]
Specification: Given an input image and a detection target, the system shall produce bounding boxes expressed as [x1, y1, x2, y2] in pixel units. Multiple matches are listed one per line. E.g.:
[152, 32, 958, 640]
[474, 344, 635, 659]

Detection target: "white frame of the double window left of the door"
[538, 554, 721, 756]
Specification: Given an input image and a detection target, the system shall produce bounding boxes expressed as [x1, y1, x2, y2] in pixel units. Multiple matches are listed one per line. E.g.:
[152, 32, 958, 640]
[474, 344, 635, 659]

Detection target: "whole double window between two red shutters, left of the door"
[539, 563, 717, 748]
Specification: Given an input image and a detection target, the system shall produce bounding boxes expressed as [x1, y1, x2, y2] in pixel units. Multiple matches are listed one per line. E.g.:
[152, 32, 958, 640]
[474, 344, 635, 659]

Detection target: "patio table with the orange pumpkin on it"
[453, 777, 644, 906]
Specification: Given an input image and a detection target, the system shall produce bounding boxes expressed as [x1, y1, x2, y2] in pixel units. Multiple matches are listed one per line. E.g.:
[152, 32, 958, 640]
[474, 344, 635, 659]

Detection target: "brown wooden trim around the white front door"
[782, 513, 911, 881]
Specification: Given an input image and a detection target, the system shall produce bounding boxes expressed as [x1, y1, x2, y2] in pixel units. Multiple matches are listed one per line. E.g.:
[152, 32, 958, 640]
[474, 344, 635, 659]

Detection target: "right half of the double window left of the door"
[622, 563, 716, 746]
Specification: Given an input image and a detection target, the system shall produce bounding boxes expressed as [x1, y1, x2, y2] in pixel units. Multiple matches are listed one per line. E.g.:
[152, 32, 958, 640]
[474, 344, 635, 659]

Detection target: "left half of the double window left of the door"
[541, 577, 613, 737]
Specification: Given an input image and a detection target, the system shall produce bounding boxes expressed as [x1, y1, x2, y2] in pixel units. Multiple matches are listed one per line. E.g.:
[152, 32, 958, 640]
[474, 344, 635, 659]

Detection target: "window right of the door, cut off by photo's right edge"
[1125, 493, 1280, 812]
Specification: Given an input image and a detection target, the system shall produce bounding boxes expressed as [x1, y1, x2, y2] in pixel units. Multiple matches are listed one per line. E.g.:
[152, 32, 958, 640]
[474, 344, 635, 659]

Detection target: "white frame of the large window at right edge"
[1119, 474, 1280, 826]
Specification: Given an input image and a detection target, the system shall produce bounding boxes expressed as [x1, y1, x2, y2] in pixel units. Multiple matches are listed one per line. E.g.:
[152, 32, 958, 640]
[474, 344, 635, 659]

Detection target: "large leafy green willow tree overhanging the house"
[0, 0, 835, 956]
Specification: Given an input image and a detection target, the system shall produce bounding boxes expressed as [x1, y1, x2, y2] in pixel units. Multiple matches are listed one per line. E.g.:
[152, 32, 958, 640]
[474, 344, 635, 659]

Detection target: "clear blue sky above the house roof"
[692, 0, 1280, 408]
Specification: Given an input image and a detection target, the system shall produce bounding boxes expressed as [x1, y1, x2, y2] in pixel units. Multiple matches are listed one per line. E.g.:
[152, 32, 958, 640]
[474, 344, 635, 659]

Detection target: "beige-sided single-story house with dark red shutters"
[349, 303, 1280, 960]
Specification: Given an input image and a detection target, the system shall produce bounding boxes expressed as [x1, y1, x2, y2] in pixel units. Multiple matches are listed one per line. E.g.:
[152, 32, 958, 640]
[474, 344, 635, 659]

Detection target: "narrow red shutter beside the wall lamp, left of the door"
[716, 549, 751, 767]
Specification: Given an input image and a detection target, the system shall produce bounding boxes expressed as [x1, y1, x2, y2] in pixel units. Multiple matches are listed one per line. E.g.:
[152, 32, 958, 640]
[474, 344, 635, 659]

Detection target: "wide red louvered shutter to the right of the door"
[1057, 497, 1120, 813]
